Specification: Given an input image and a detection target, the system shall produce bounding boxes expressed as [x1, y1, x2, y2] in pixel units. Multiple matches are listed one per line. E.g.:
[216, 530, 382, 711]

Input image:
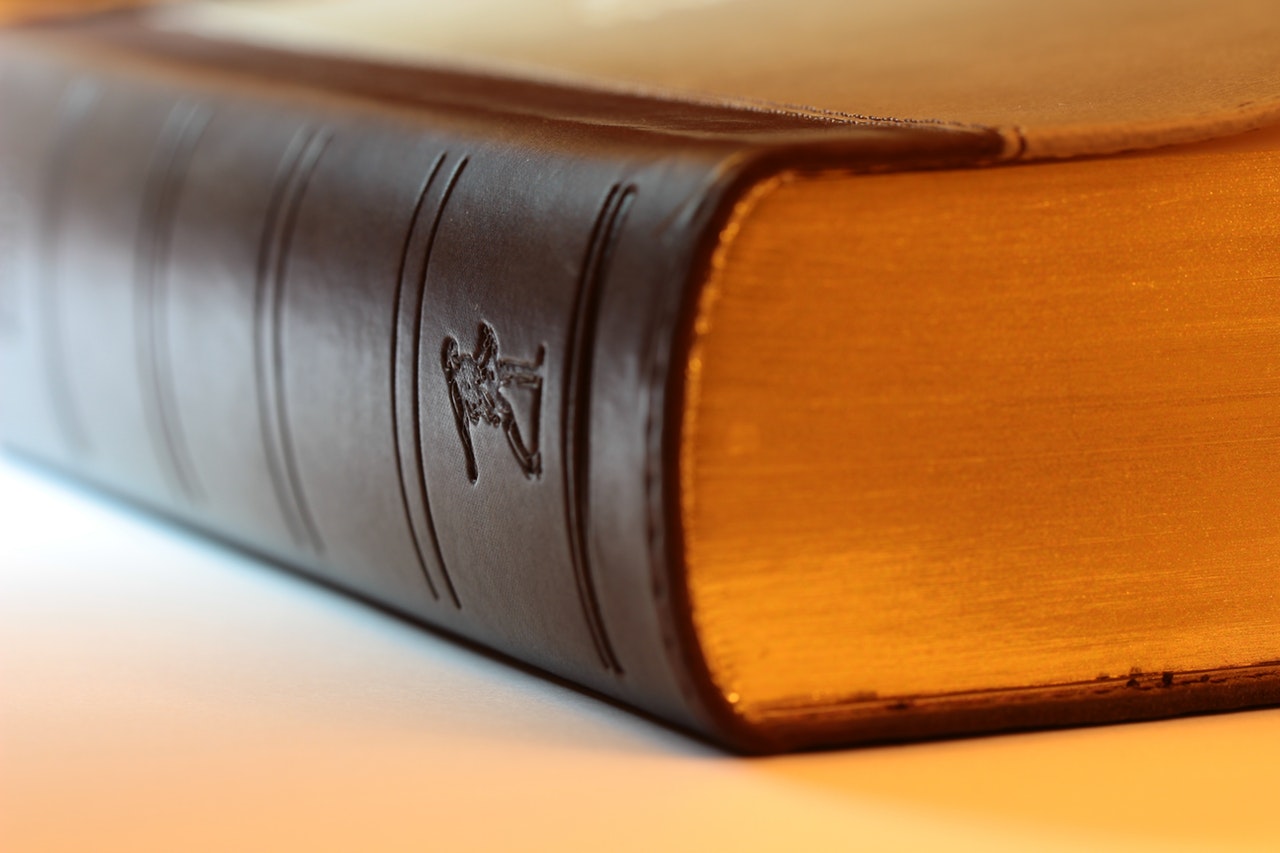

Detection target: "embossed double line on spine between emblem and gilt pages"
[561, 184, 636, 675]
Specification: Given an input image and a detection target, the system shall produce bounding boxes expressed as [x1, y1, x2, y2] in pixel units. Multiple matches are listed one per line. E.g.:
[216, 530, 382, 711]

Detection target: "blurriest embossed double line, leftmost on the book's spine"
[38, 79, 100, 453]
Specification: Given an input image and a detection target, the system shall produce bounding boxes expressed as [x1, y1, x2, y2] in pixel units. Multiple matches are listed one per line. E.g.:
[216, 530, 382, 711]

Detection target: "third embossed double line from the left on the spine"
[253, 128, 330, 553]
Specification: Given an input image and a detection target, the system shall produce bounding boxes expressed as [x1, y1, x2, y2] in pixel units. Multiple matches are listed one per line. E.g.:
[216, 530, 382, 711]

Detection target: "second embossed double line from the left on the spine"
[134, 101, 211, 501]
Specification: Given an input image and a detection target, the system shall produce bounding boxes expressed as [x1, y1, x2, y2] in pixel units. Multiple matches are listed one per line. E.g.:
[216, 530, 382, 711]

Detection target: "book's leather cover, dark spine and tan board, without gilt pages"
[0, 0, 1280, 751]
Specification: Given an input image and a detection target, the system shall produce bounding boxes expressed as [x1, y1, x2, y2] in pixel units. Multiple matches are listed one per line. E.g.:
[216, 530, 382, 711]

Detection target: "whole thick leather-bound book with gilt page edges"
[0, 0, 1280, 752]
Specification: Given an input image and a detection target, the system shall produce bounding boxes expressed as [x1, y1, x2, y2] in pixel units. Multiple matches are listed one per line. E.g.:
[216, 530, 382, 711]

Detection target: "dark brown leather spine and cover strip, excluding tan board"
[0, 9, 1275, 752]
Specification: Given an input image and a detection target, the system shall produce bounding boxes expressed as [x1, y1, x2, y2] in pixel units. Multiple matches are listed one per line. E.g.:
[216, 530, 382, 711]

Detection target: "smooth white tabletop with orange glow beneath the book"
[0, 460, 1280, 853]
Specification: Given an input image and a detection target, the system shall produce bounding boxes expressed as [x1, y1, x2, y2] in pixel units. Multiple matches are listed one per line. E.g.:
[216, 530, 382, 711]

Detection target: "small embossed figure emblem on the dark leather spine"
[440, 323, 545, 483]
